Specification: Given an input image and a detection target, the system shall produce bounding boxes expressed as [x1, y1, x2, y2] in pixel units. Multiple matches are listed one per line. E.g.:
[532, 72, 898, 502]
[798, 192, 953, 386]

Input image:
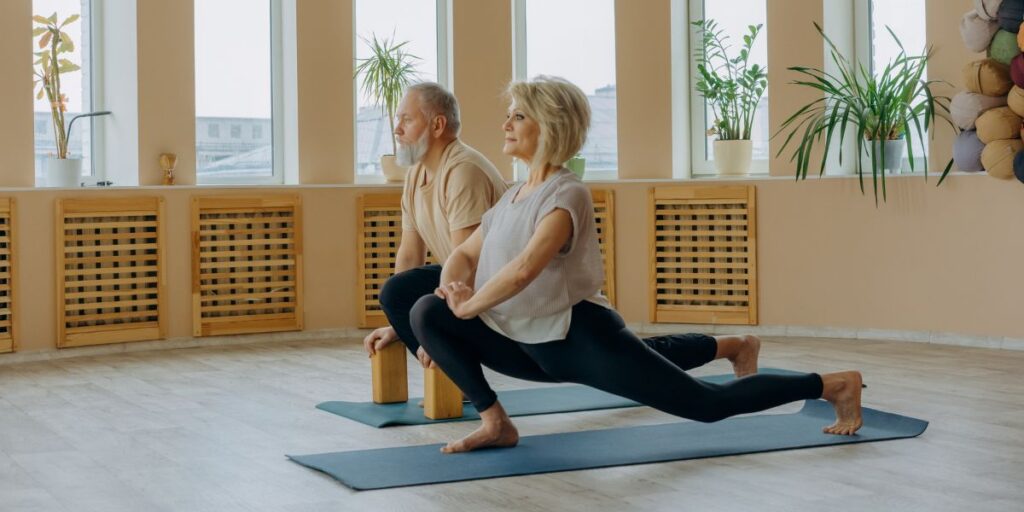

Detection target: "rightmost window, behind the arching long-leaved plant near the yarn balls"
[855, 0, 928, 172]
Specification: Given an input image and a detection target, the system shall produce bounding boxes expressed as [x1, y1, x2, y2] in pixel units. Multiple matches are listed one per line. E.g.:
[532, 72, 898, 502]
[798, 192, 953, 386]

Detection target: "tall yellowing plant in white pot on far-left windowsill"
[32, 12, 110, 186]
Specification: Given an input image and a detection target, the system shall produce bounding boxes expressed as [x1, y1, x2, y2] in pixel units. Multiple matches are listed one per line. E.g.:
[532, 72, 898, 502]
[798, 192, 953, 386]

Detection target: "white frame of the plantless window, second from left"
[189, 0, 285, 185]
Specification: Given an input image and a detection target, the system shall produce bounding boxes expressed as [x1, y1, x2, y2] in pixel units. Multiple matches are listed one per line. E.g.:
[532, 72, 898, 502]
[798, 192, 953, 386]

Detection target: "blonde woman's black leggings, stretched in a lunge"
[412, 295, 822, 422]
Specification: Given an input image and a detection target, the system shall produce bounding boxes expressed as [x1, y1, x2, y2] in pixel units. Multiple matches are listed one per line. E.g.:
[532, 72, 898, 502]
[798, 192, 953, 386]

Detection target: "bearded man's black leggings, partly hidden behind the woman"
[380, 265, 718, 370]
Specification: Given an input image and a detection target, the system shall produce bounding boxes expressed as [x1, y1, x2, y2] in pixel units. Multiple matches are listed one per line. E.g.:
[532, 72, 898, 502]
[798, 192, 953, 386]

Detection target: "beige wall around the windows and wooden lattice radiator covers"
[0, 0, 1011, 351]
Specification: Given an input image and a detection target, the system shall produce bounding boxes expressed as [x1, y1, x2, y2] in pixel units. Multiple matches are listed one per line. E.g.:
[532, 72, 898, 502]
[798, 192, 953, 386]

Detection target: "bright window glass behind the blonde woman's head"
[514, 0, 618, 179]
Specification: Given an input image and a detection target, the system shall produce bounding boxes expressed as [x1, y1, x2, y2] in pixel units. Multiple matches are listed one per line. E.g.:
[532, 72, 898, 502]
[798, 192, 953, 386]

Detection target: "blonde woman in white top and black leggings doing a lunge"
[411, 77, 862, 453]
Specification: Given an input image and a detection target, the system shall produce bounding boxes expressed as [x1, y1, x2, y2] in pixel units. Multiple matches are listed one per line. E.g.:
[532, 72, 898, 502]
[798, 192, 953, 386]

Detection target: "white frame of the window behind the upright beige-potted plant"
[684, 0, 771, 178]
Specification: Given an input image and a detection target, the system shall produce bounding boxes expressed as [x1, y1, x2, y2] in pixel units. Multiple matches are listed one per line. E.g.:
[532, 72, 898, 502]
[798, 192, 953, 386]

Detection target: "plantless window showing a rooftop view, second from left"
[195, 0, 284, 183]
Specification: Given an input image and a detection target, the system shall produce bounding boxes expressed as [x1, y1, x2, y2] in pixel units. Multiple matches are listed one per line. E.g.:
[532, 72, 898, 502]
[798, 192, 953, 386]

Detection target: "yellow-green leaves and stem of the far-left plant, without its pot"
[32, 12, 81, 159]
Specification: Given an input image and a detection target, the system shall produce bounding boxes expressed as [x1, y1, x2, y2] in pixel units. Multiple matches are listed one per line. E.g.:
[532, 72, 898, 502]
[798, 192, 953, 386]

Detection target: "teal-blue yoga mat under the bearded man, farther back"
[316, 368, 802, 428]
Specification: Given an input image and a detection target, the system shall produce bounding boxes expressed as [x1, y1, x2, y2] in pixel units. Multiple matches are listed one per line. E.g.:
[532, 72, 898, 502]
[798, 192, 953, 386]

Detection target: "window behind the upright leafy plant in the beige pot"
[686, 0, 772, 175]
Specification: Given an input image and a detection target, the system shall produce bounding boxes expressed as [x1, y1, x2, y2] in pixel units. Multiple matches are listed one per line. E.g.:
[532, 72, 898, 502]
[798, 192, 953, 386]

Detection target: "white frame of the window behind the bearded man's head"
[352, 0, 455, 184]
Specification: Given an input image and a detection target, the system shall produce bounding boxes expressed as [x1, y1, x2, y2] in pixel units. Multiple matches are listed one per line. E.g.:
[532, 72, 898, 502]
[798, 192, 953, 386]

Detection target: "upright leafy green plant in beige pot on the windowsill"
[692, 19, 768, 174]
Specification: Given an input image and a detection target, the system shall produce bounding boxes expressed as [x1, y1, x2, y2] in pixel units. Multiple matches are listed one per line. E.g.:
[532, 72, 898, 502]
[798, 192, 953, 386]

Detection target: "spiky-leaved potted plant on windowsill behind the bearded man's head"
[355, 34, 420, 181]
